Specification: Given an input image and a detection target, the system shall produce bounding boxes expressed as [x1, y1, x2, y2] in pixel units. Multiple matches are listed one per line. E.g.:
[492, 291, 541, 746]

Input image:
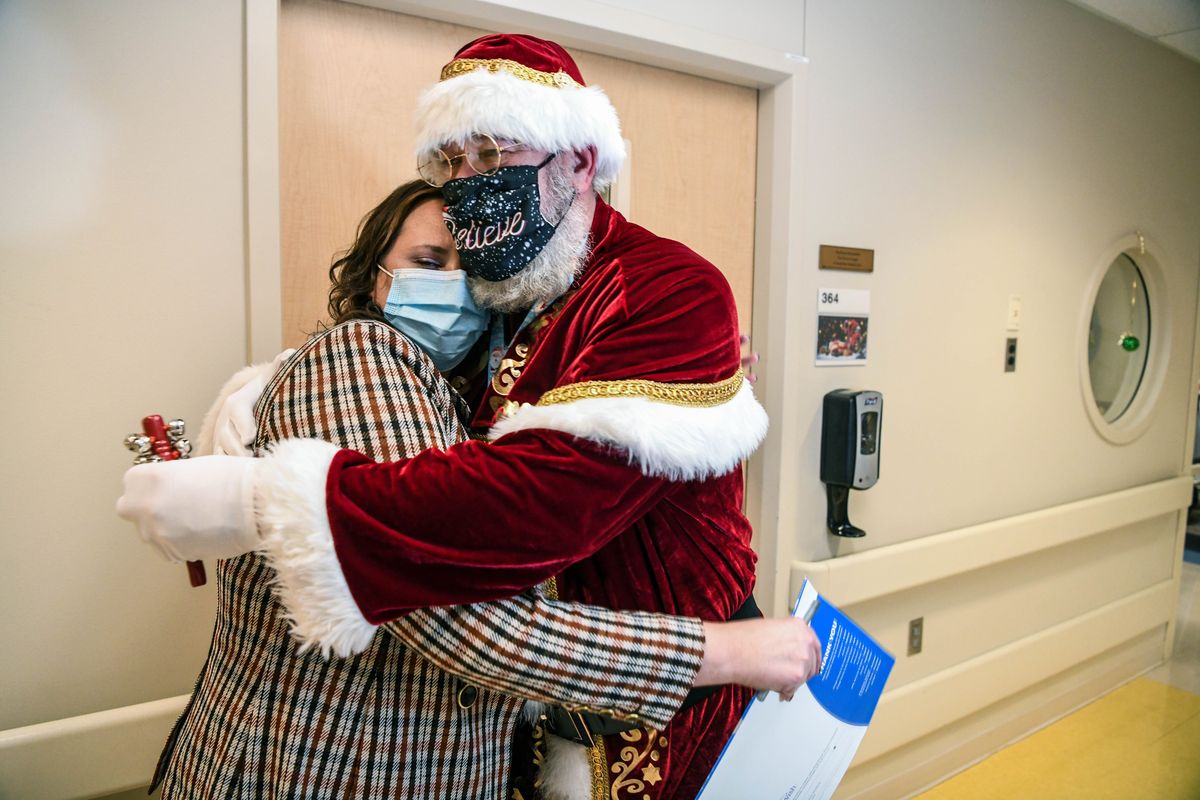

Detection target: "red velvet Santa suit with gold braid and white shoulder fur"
[260, 201, 766, 799]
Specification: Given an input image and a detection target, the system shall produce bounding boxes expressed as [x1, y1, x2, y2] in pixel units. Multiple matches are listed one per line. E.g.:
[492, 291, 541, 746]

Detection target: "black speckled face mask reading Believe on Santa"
[442, 154, 565, 281]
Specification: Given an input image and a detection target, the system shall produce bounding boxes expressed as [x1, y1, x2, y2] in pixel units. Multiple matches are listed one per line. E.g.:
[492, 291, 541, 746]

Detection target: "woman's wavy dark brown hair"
[329, 180, 442, 325]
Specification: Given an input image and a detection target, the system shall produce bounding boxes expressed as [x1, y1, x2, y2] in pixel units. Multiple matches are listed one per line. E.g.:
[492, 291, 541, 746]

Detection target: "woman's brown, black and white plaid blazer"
[155, 321, 703, 800]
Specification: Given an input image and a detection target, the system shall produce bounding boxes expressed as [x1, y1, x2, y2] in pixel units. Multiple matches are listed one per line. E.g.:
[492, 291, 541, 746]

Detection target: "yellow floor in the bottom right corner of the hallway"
[918, 678, 1200, 800]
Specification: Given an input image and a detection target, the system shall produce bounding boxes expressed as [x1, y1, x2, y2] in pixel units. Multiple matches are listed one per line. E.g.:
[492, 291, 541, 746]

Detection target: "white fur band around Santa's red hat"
[416, 68, 625, 188]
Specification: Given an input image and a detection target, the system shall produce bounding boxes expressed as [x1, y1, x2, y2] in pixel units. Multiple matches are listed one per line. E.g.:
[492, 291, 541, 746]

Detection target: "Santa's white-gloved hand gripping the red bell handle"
[116, 456, 259, 561]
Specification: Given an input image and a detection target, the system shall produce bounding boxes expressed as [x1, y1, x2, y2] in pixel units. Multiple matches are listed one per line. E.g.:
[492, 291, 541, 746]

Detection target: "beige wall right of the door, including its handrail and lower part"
[787, 0, 1200, 799]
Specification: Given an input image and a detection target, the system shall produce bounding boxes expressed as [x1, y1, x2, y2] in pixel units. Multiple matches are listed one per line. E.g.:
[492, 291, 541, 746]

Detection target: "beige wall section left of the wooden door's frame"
[0, 0, 246, 796]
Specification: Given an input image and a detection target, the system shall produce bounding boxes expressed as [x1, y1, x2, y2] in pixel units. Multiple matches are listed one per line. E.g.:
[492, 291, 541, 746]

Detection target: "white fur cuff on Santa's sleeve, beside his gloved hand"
[254, 439, 377, 658]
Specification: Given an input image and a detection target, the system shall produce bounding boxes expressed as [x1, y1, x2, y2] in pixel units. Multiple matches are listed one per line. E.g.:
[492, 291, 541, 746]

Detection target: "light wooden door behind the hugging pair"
[280, 0, 757, 347]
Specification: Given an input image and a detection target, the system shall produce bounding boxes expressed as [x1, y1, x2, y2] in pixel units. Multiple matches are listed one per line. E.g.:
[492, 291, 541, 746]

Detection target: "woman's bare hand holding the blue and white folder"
[696, 616, 821, 700]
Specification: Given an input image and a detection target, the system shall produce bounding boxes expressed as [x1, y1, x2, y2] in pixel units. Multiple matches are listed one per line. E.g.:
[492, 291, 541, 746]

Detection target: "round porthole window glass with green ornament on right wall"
[1087, 253, 1151, 422]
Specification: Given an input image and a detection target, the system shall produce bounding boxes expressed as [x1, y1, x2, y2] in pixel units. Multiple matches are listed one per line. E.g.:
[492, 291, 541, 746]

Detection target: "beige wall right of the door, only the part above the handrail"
[794, 0, 1200, 559]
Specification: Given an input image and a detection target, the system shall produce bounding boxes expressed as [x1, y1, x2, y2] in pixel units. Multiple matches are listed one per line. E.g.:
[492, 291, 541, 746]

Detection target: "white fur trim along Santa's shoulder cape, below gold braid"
[492, 380, 767, 481]
